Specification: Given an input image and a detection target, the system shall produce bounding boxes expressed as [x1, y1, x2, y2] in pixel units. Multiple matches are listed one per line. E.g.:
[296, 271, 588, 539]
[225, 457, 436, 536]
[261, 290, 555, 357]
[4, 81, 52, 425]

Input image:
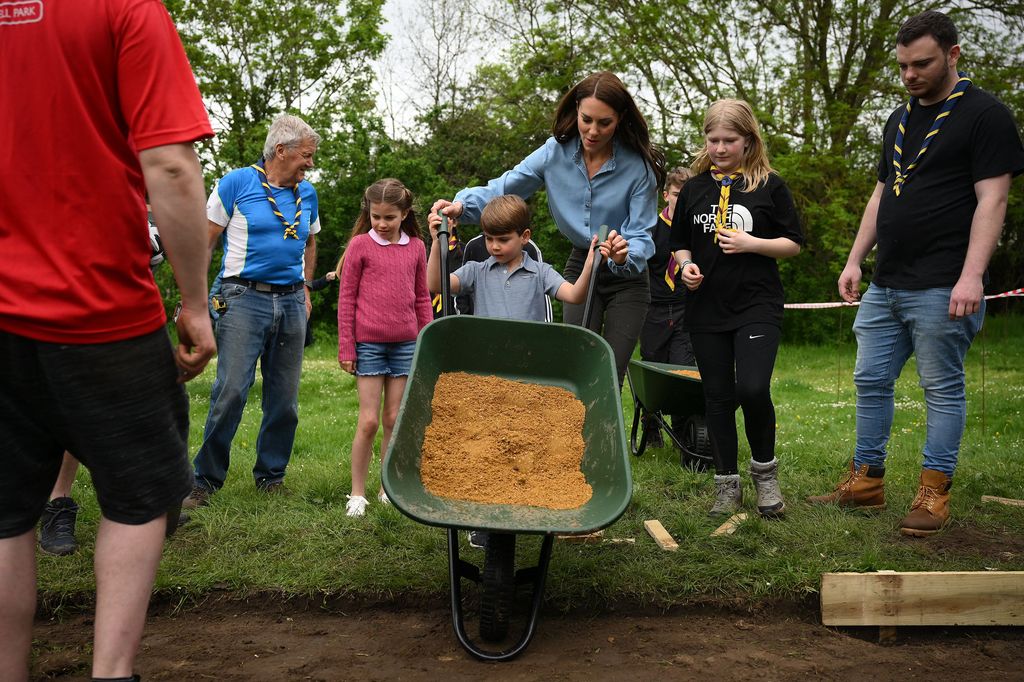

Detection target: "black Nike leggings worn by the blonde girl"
[690, 324, 781, 475]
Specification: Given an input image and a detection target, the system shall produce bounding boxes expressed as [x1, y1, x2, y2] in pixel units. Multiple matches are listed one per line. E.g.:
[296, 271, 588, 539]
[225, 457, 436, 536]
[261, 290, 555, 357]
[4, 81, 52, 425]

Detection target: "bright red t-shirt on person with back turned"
[0, 0, 213, 343]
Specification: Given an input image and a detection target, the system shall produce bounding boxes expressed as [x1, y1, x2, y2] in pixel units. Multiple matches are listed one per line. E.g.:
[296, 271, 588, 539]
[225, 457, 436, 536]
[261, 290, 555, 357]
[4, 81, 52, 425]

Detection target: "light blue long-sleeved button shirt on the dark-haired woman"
[455, 136, 657, 275]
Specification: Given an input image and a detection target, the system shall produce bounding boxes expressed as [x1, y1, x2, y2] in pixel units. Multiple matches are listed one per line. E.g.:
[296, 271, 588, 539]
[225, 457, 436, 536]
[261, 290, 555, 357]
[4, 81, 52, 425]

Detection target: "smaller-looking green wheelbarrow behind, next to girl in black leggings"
[627, 359, 715, 469]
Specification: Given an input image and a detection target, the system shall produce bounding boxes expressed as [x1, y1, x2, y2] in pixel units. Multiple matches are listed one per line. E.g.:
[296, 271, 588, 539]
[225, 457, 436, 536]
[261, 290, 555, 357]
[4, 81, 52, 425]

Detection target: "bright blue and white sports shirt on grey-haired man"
[206, 168, 321, 285]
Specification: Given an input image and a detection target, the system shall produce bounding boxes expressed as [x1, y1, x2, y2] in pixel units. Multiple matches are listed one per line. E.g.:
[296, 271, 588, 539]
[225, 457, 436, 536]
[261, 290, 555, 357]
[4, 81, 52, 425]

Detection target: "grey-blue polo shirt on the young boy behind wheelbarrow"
[453, 251, 565, 322]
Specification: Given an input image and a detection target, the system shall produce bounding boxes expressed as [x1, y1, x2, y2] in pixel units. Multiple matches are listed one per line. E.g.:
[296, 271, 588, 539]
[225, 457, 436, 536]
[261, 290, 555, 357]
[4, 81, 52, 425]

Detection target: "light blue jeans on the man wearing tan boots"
[853, 284, 985, 476]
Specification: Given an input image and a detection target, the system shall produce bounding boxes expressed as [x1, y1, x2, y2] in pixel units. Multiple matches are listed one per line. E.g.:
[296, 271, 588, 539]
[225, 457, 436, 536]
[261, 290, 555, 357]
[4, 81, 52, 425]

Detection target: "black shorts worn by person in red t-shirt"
[0, 329, 193, 538]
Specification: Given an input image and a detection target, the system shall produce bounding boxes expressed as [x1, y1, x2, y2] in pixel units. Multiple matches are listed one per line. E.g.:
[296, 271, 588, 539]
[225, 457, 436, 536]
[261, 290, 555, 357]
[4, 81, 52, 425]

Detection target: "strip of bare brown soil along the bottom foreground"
[32, 596, 1024, 682]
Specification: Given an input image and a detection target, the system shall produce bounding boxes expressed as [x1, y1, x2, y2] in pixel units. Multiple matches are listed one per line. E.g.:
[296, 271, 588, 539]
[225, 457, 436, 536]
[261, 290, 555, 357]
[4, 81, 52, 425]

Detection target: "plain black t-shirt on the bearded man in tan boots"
[873, 86, 1024, 289]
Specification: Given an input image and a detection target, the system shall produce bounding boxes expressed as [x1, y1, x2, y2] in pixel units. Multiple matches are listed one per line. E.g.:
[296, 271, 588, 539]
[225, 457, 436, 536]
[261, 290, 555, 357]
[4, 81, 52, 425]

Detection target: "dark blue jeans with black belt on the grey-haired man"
[193, 284, 306, 491]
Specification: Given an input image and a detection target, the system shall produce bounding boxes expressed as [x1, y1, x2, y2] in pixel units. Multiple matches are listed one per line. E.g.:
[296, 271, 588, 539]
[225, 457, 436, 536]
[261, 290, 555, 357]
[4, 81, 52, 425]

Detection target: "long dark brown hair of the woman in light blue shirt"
[551, 71, 665, 186]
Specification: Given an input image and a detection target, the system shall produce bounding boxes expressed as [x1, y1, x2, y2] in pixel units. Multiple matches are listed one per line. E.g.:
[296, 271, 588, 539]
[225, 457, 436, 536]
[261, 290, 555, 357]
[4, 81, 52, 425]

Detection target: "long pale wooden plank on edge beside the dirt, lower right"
[821, 570, 1024, 626]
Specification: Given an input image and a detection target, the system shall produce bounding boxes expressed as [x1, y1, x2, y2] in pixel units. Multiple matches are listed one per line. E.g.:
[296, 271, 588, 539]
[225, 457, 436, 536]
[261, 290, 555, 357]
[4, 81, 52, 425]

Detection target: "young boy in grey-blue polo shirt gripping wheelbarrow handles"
[427, 195, 629, 315]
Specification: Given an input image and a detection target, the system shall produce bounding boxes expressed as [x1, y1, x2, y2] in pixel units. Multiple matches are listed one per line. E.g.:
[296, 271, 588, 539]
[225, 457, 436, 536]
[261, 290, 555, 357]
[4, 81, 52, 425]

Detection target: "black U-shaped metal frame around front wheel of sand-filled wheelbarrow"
[447, 528, 555, 662]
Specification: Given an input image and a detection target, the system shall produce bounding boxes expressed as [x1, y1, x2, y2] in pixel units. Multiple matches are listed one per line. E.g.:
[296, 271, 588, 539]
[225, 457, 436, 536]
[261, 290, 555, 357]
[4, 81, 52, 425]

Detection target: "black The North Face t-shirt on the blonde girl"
[669, 172, 804, 332]
